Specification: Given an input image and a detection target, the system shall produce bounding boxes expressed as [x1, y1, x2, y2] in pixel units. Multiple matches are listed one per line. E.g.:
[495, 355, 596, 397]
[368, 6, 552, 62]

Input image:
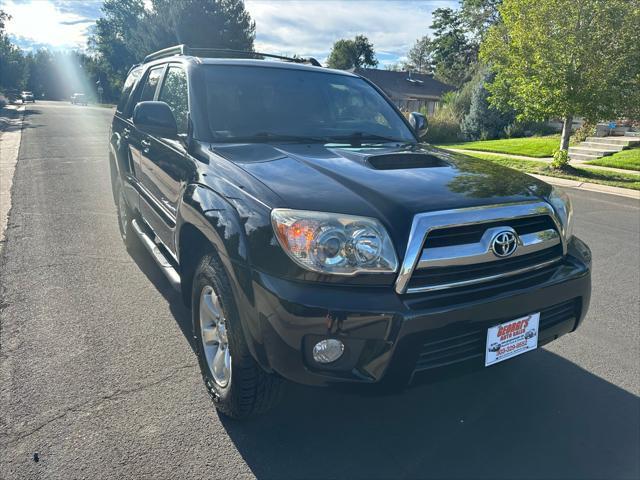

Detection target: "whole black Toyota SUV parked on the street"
[109, 46, 591, 417]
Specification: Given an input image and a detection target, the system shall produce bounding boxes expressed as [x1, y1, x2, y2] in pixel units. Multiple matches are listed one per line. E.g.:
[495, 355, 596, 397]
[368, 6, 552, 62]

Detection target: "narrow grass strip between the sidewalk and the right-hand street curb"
[470, 153, 640, 190]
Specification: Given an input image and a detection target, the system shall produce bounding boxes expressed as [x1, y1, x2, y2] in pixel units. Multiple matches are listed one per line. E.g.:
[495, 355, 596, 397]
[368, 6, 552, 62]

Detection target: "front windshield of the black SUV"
[205, 65, 415, 145]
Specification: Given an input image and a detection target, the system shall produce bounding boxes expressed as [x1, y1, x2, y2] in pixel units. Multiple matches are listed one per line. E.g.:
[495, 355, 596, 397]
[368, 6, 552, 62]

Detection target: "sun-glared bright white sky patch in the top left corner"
[2, 0, 94, 48]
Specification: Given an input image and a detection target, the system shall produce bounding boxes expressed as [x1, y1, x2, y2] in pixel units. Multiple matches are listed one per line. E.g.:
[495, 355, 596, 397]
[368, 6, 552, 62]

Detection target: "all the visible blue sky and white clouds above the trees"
[0, 0, 458, 65]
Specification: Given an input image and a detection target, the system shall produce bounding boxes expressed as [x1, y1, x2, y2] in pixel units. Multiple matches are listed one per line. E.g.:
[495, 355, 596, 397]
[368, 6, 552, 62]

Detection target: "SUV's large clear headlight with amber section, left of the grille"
[271, 208, 398, 275]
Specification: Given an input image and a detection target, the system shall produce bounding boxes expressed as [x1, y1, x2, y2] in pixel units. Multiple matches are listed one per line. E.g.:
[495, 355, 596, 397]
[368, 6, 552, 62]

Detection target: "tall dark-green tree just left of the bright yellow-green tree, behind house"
[431, 8, 477, 87]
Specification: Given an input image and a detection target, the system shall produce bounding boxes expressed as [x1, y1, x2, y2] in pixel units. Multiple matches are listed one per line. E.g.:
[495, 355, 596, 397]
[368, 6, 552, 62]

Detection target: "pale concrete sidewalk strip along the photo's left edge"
[0, 105, 25, 248]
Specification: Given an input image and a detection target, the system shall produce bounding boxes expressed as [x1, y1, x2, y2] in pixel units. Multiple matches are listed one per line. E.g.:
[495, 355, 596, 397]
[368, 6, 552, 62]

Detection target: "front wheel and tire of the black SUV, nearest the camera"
[191, 253, 284, 419]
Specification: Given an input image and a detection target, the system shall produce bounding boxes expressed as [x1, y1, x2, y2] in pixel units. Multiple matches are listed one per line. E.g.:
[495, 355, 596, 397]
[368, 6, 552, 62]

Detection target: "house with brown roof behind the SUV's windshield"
[350, 68, 454, 115]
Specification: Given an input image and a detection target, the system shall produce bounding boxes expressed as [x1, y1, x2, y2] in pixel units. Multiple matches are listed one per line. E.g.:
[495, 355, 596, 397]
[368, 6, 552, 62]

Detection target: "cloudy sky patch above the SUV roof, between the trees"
[245, 0, 458, 65]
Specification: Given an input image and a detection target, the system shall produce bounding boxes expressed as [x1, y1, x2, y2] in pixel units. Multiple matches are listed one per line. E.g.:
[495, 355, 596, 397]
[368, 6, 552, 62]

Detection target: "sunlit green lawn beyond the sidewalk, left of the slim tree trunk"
[438, 135, 560, 158]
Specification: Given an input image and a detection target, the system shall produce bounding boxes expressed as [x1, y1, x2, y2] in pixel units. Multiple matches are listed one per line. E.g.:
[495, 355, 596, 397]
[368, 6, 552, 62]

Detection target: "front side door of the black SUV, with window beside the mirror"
[141, 64, 195, 252]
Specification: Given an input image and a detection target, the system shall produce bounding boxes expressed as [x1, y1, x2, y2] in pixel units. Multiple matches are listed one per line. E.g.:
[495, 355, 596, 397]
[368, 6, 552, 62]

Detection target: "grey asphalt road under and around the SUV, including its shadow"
[0, 102, 640, 479]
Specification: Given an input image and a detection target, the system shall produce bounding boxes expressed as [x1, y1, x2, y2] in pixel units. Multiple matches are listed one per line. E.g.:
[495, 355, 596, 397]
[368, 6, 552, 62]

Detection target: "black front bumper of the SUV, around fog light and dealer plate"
[246, 237, 591, 385]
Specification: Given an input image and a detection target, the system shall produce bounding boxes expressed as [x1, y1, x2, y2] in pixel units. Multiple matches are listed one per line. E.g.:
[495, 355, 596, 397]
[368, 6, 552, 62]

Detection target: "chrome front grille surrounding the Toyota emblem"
[396, 202, 566, 293]
